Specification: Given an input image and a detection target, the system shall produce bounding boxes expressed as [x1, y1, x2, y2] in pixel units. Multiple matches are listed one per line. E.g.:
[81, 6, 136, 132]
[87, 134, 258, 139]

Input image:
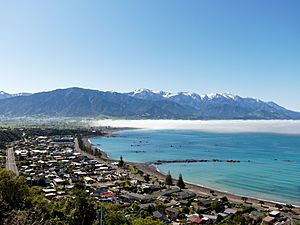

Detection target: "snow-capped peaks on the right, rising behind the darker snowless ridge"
[127, 89, 298, 119]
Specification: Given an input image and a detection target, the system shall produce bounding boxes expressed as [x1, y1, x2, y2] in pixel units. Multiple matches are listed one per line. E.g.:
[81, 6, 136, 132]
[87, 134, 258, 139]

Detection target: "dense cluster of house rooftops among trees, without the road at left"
[11, 136, 298, 225]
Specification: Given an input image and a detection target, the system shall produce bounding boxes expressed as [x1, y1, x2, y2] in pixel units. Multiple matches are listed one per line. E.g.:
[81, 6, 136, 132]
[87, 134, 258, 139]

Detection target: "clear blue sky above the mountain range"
[0, 0, 300, 111]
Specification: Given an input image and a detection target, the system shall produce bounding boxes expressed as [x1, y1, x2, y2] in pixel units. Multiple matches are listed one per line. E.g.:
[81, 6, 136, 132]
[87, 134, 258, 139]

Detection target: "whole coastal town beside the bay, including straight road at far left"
[0, 128, 300, 225]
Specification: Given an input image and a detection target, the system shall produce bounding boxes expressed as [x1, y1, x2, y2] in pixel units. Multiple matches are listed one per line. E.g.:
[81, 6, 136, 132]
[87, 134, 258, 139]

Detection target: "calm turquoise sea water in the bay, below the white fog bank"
[91, 130, 300, 205]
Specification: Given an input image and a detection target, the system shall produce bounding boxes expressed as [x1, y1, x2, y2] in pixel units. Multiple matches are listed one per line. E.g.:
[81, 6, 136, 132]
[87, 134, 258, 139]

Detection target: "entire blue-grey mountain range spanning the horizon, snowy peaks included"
[0, 88, 300, 120]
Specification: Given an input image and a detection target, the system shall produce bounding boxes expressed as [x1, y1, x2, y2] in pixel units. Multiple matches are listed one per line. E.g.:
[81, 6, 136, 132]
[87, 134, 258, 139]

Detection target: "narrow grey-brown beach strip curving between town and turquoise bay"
[84, 132, 300, 211]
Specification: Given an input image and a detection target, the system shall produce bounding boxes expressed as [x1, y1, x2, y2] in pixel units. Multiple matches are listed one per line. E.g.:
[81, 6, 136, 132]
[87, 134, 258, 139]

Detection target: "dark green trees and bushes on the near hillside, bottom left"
[0, 169, 169, 225]
